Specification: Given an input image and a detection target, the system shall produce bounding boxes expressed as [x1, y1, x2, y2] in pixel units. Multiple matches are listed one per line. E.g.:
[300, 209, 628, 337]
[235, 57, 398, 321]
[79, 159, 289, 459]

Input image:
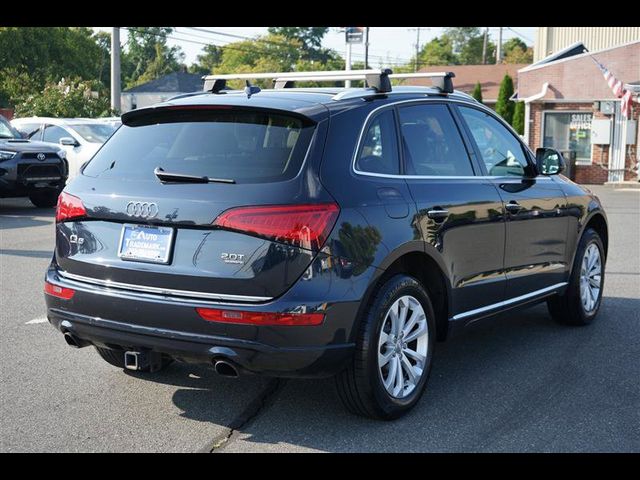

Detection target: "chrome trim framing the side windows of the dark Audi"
[351, 96, 551, 181]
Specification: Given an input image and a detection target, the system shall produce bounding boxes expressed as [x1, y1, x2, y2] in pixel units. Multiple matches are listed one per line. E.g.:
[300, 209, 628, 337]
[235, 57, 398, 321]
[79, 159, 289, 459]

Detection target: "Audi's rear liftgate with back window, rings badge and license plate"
[56, 108, 335, 301]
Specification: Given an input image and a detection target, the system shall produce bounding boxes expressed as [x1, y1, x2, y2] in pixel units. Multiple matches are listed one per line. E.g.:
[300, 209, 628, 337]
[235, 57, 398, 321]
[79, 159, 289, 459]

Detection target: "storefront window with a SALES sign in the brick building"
[542, 112, 593, 163]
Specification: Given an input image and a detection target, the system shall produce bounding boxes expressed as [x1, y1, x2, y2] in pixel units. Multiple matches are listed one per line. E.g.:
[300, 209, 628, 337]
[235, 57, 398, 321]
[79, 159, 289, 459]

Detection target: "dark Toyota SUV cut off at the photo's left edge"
[0, 115, 67, 207]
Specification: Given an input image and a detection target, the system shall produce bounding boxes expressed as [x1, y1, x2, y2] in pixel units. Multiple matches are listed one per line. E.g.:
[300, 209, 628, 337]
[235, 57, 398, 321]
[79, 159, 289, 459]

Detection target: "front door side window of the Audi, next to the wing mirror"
[460, 107, 527, 177]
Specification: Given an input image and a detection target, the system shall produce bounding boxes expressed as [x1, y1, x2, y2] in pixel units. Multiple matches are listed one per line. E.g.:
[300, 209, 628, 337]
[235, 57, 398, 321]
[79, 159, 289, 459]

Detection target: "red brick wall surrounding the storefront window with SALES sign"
[529, 102, 640, 184]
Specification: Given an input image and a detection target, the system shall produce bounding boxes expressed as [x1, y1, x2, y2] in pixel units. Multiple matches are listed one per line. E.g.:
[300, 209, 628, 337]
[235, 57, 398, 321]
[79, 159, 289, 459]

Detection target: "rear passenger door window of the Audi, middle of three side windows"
[400, 105, 473, 176]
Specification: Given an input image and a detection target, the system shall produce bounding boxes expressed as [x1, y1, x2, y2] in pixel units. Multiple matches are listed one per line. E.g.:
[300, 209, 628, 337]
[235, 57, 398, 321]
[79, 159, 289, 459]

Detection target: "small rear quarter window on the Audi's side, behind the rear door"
[356, 110, 400, 175]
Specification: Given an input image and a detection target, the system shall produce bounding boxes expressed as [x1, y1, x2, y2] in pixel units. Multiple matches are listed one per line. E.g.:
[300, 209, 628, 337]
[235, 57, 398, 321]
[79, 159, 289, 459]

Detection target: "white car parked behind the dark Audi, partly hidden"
[11, 117, 116, 181]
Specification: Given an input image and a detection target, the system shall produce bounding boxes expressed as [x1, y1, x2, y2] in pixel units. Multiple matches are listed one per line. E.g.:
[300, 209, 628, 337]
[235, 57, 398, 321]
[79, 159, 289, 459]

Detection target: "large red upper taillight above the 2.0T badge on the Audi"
[213, 203, 340, 249]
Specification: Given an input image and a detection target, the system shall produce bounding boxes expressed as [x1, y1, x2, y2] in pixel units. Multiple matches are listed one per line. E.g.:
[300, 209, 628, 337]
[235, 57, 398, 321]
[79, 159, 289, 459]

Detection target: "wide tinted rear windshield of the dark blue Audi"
[83, 111, 313, 183]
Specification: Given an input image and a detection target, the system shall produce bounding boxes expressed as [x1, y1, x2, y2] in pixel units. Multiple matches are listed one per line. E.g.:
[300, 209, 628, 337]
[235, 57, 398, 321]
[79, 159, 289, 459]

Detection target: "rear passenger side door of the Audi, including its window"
[398, 102, 505, 317]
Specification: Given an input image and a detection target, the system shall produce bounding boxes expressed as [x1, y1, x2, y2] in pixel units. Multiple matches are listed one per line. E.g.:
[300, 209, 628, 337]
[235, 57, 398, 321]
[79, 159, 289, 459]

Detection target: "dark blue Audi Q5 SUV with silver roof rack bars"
[45, 71, 609, 419]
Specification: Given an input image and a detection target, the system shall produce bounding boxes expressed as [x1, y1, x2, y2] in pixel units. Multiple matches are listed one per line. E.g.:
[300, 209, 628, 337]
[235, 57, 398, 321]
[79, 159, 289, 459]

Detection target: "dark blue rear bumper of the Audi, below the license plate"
[45, 266, 370, 378]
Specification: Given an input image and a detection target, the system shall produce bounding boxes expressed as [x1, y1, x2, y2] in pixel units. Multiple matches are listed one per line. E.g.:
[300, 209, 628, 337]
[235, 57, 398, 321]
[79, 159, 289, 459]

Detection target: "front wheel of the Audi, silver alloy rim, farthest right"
[547, 228, 604, 325]
